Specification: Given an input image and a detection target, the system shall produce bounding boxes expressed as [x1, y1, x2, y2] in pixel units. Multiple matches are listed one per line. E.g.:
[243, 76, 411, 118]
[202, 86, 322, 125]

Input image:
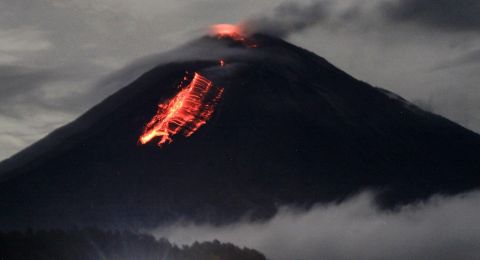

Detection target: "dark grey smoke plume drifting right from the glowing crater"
[244, 1, 330, 38]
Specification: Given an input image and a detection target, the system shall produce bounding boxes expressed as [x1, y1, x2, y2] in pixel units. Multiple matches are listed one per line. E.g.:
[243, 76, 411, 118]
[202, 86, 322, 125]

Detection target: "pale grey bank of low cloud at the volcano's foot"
[153, 192, 480, 260]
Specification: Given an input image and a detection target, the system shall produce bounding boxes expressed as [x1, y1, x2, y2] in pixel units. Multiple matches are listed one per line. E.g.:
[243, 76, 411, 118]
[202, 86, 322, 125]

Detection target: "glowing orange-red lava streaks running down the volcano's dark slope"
[139, 73, 223, 146]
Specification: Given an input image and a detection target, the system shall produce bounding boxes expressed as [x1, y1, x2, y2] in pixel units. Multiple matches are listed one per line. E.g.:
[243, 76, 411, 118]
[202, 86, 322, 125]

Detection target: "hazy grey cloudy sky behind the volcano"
[0, 0, 480, 160]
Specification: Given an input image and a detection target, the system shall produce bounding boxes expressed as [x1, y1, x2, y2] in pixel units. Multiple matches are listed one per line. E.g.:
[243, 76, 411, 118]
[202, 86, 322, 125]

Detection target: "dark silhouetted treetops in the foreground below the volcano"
[0, 228, 265, 260]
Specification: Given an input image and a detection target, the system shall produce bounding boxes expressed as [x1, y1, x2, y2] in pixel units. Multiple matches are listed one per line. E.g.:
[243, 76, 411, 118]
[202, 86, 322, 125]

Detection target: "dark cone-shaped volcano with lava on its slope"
[0, 34, 480, 229]
